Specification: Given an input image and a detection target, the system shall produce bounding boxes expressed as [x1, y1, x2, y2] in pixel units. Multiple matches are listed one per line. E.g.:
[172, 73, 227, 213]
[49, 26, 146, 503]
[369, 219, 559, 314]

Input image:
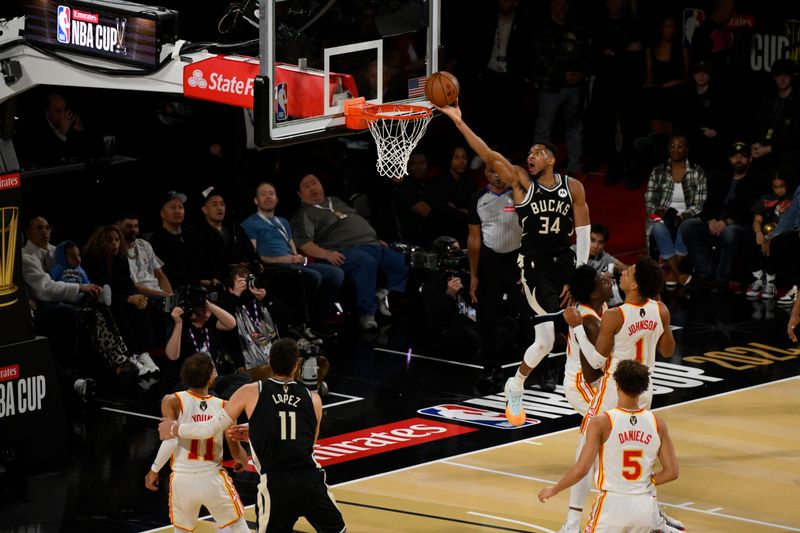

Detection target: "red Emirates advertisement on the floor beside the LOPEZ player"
[314, 418, 477, 466]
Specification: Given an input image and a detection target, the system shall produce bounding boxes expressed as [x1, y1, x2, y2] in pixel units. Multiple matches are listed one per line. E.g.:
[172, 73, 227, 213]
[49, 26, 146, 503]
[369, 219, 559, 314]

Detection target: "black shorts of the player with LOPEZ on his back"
[256, 469, 346, 533]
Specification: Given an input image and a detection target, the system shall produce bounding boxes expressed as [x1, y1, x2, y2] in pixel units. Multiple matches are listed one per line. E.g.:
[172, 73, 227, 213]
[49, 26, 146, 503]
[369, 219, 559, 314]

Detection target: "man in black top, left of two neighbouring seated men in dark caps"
[147, 191, 190, 290]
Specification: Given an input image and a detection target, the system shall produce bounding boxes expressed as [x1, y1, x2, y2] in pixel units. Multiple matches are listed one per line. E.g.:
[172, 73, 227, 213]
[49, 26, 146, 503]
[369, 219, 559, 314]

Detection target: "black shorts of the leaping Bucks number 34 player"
[520, 248, 575, 316]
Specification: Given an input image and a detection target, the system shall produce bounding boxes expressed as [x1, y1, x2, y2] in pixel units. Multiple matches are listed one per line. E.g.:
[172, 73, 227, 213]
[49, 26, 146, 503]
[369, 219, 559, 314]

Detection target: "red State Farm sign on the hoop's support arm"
[183, 56, 258, 109]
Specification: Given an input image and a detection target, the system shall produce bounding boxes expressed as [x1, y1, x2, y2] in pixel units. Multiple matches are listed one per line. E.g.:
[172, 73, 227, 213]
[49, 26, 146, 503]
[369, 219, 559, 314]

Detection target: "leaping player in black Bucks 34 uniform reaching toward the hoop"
[437, 103, 590, 426]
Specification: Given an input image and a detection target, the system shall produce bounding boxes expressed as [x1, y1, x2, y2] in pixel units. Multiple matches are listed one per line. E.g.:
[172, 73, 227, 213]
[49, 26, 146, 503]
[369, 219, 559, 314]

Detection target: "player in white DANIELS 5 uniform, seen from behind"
[539, 359, 678, 533]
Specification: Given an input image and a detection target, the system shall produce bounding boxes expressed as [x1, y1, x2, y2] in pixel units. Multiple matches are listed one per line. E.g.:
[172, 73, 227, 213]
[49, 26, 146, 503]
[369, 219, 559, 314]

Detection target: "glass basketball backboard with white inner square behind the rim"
[254, 0, 440, 145]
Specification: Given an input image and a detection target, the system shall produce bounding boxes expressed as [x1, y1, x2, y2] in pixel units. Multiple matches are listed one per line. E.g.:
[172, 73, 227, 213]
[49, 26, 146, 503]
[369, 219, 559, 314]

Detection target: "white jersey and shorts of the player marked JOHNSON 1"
[581, 299, 664, 433]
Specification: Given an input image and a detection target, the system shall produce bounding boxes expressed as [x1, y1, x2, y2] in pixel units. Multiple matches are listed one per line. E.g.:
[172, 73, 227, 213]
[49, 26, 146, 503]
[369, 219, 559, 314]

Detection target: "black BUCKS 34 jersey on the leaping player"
[514, 174, 574, 257]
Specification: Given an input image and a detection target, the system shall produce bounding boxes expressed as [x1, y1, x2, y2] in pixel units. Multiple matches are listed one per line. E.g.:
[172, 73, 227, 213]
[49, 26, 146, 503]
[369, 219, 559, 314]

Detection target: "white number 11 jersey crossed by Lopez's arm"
[171, 391, 225, 474]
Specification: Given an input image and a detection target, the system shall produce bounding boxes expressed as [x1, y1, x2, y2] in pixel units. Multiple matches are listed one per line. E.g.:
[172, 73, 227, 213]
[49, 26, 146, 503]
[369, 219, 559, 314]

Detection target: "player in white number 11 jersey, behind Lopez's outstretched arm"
[144, 353, 250, 533]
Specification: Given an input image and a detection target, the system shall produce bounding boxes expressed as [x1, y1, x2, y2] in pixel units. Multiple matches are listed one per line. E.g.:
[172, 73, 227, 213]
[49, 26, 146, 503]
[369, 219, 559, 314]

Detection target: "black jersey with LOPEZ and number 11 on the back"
[250, 379, 318, 474]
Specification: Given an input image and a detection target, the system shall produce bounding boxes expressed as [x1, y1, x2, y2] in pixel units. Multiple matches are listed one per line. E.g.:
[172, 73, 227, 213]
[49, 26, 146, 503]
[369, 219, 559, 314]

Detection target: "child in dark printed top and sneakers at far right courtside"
[747, 174, 797, 299]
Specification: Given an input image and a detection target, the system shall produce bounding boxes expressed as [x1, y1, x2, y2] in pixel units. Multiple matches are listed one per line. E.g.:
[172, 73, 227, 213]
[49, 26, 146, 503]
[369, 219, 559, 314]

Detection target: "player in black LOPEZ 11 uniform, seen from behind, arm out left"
[158, 339, 346, 533]
